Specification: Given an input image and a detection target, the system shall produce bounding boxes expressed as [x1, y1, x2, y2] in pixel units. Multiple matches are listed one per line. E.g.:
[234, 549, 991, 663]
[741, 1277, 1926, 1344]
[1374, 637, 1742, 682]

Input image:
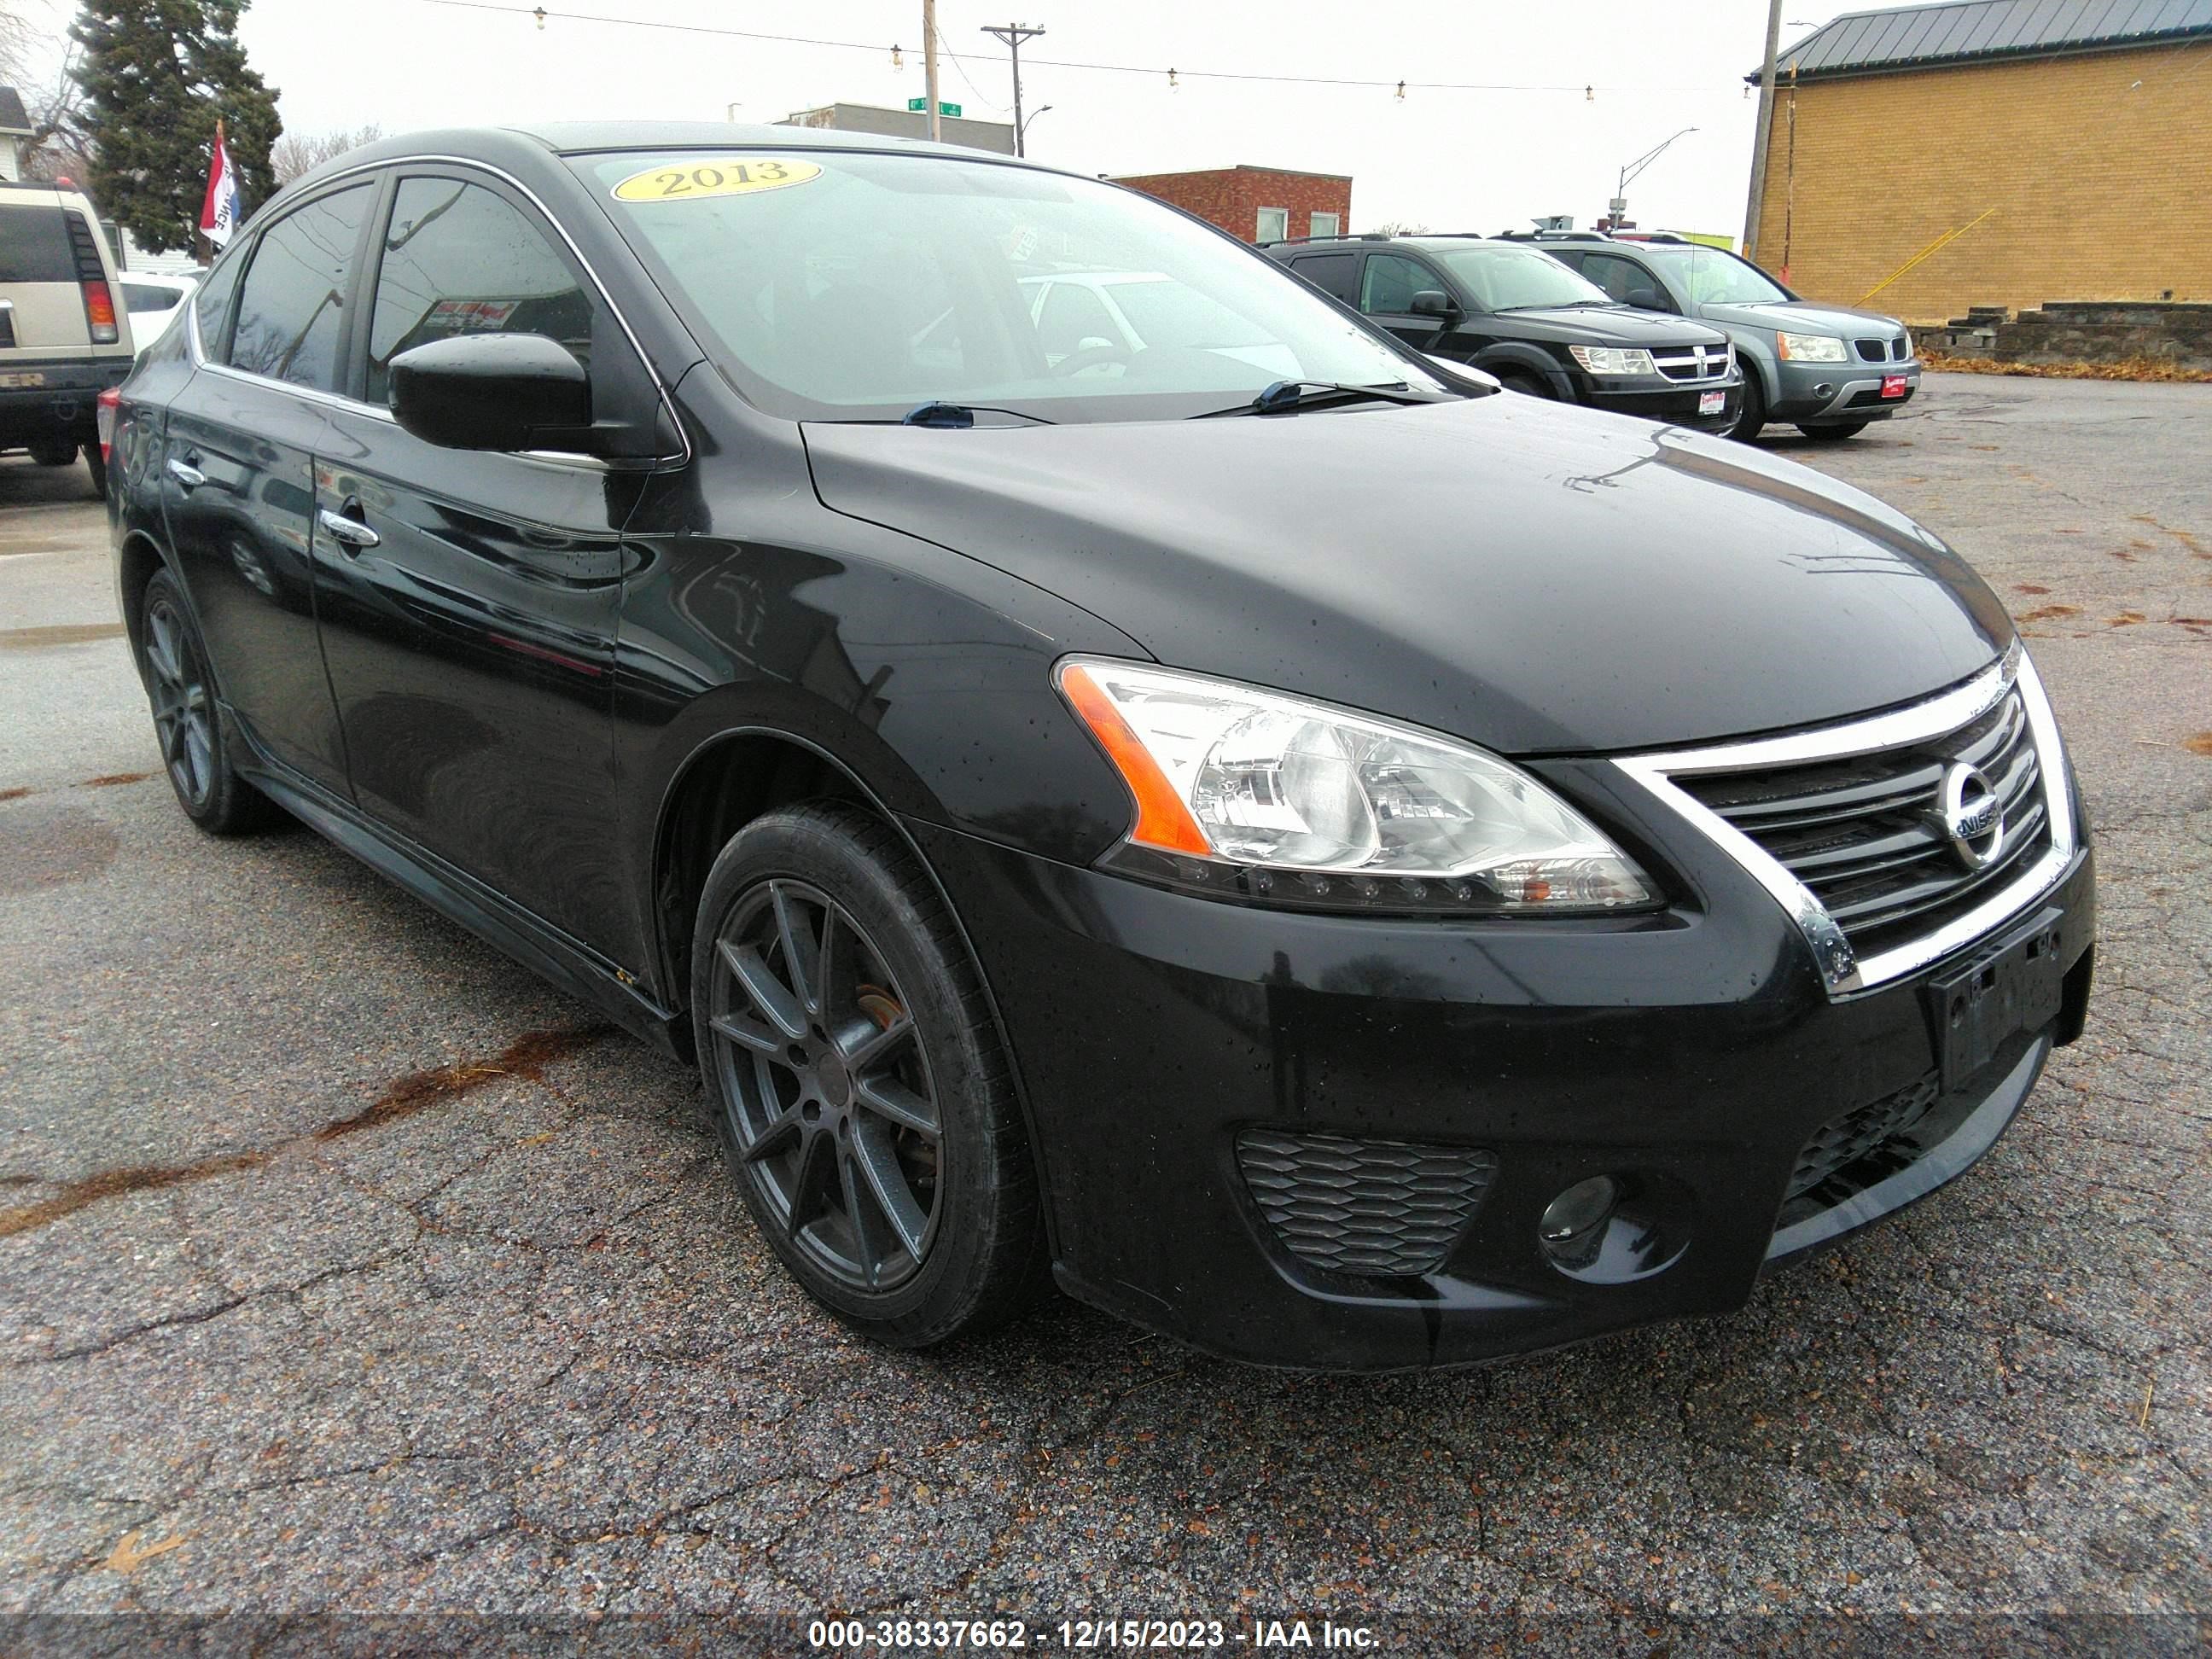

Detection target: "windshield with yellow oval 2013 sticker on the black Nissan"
[573, 150, 1440, 420]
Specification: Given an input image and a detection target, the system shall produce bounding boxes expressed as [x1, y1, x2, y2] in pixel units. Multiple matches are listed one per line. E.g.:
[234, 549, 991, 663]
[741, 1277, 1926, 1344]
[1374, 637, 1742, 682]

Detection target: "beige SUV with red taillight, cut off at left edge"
[0, 183, 133, 493]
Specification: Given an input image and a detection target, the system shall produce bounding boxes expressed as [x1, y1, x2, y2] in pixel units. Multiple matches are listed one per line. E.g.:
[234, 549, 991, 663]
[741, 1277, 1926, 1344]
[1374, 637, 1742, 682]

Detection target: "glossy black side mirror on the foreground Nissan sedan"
[392, 334, 602, 453]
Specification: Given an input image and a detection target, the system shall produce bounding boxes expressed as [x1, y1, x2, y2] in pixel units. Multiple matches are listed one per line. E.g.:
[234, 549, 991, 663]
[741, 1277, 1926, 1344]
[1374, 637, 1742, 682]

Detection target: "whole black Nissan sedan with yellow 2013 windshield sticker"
[111, 126, 2093, 1369]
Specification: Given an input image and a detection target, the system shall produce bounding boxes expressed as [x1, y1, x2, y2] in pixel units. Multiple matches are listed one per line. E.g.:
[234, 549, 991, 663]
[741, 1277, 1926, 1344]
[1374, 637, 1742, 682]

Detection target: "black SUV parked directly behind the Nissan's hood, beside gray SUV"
[1267, 235, 1743, 434]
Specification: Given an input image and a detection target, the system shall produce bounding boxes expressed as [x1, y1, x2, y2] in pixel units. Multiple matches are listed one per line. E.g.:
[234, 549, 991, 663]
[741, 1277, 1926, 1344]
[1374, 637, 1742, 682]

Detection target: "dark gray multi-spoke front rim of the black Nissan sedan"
[707, 881, 945, 1292]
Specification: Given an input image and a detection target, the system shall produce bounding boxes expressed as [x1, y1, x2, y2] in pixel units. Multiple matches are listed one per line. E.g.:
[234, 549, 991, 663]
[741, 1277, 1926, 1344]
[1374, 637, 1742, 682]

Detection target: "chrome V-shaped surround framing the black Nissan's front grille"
[1613, 639, 2075, 998]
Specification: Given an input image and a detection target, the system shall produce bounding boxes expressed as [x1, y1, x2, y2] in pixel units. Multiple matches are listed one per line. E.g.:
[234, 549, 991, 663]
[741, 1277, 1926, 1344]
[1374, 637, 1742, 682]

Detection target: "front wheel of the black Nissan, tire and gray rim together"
[690, 800, 1044, 1348]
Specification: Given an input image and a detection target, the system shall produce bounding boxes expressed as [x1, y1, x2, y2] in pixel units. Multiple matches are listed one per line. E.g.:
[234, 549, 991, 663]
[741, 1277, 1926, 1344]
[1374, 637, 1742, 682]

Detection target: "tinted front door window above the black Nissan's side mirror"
[365, 179, 593, 403]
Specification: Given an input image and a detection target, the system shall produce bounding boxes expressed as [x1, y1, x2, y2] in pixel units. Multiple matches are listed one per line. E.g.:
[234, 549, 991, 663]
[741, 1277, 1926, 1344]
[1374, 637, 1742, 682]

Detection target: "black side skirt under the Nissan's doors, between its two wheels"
[224, 707, 692, 1060]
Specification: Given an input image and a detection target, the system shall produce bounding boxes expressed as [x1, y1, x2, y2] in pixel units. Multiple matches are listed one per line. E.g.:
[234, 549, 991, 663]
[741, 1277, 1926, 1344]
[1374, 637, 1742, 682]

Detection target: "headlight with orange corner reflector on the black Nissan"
[1053, 657, 1656, 913]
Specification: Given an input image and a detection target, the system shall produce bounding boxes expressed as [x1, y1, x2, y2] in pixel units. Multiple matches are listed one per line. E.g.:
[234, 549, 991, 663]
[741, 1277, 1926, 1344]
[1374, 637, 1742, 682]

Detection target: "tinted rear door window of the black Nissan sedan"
[230, 183, 376, 392]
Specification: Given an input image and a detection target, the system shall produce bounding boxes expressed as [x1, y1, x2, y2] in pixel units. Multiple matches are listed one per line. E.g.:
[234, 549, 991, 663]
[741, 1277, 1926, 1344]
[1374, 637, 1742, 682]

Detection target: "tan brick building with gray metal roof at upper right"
[1752, 0, 2212, 323]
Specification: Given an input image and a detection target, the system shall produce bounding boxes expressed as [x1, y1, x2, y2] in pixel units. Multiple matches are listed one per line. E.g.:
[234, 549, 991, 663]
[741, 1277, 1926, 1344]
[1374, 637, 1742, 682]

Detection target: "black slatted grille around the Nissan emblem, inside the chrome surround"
[1679, 686, 2051, 956]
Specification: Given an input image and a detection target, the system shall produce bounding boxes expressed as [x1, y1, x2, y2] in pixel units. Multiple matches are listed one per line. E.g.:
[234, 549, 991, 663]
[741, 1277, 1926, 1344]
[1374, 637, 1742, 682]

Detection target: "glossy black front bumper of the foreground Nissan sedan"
[911, 787, 2095, 1371]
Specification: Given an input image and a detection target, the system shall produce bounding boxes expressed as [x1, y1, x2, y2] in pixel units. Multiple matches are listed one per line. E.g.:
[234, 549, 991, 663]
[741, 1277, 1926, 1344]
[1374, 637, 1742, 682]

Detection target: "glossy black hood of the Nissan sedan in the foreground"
[805, 393, 2011, 754]
